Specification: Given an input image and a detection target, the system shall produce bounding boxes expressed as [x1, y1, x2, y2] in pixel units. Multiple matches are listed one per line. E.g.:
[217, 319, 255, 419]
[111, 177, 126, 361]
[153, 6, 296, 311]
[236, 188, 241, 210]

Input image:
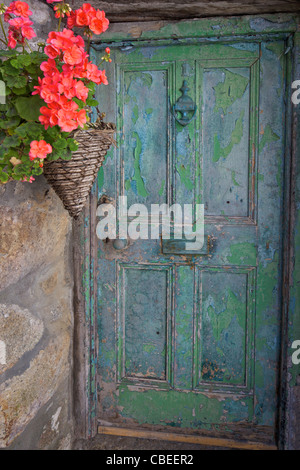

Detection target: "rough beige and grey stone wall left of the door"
[0, 0, 73, 449]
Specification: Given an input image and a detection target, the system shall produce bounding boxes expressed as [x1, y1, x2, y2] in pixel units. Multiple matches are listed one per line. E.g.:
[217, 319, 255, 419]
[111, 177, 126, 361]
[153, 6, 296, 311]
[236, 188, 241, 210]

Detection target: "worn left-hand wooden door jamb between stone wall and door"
[73, 185, 98, 440]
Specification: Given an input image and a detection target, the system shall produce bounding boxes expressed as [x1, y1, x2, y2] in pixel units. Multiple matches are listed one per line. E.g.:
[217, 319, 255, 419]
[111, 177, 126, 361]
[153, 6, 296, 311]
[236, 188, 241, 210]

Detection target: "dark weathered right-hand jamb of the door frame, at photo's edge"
[278, 31, 300, 450]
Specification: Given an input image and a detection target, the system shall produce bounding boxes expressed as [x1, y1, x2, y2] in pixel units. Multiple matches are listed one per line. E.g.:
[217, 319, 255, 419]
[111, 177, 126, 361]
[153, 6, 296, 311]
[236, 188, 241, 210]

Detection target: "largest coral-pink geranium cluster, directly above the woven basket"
[33, 29, 108, 132]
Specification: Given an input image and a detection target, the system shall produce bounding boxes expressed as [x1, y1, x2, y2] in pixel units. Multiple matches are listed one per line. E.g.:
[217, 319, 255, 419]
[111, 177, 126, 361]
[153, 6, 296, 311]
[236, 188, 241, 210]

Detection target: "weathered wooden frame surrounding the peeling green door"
[73, 14, 300, 449]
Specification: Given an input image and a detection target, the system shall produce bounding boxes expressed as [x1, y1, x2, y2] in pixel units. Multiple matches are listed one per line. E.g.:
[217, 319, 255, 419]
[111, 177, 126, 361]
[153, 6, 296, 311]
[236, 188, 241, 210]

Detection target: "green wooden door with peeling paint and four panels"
[92, 35, 286, 442]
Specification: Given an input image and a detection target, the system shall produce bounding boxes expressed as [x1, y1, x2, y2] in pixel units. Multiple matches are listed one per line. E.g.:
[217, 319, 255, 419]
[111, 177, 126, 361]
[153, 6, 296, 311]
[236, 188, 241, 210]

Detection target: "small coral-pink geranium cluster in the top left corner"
[4, 0, 36, 49]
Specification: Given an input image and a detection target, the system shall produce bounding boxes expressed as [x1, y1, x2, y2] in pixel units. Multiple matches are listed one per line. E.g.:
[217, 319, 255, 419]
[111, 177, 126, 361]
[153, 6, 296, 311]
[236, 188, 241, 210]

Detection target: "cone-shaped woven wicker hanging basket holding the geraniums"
[44, 128, 115, 218]
